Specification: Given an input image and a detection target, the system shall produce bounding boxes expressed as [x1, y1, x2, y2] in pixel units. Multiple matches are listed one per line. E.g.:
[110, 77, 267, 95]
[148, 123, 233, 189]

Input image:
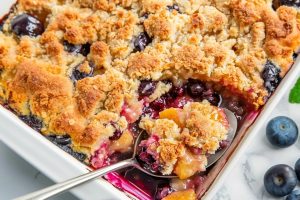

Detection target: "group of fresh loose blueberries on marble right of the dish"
[264, 116, 300, 200]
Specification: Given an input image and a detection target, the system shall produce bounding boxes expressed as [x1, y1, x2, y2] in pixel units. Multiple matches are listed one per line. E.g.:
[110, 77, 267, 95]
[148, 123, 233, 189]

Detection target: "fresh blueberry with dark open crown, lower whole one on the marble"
[264, 164, 297, 197]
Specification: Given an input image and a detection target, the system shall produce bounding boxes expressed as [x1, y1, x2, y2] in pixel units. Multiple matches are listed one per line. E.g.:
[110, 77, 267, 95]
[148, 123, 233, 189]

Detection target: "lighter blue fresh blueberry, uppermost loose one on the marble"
[266, 116, 298, 148]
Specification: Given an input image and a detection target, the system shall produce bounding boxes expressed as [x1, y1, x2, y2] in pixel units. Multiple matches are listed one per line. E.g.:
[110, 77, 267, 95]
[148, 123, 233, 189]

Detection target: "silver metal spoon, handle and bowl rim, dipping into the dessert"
[15, 109, 237, 200]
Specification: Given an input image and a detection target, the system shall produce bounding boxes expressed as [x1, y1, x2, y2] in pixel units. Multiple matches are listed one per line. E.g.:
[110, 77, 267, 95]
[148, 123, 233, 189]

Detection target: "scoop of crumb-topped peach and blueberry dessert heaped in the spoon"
[140, 101, 229, 179]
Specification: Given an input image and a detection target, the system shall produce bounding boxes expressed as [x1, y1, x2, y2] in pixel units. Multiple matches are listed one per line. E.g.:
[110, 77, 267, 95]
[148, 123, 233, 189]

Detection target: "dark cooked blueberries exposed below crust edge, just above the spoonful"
[138, 79, 246, 120]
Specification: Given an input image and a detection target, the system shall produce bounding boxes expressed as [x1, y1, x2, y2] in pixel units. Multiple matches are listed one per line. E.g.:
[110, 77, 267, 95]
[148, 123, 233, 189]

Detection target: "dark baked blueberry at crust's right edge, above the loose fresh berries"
[261, 60, 281, 94]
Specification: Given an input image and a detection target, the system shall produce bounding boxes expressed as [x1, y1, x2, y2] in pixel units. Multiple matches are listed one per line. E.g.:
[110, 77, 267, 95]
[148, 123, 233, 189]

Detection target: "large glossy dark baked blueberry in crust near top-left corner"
[11, 13, 44, 37]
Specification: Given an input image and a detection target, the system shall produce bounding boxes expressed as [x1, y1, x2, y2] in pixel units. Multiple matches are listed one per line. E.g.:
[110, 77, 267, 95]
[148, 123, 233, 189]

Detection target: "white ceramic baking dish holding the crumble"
[0, 0, 300, 200]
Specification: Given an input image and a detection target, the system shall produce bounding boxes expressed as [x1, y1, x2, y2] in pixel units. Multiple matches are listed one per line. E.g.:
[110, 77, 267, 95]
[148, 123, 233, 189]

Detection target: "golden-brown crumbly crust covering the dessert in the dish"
[0, 0, 300, 162]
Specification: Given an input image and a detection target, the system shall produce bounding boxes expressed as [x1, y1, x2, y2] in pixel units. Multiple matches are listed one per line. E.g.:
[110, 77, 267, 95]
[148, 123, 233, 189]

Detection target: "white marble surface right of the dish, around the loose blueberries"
[213, 82, 300, 200]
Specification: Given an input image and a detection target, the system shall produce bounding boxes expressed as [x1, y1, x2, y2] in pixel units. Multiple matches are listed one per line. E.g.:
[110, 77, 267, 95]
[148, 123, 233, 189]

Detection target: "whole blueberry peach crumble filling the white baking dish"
[0, 0, 300, 199]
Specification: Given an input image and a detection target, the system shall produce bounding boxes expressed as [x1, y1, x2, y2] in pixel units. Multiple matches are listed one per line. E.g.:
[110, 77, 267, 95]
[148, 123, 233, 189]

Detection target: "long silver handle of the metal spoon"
[15, 159, 136, 200]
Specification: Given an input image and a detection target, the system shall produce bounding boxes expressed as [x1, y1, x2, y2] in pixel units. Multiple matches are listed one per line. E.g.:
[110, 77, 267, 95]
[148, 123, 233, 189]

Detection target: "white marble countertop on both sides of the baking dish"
[0, 82, 300, 200]
